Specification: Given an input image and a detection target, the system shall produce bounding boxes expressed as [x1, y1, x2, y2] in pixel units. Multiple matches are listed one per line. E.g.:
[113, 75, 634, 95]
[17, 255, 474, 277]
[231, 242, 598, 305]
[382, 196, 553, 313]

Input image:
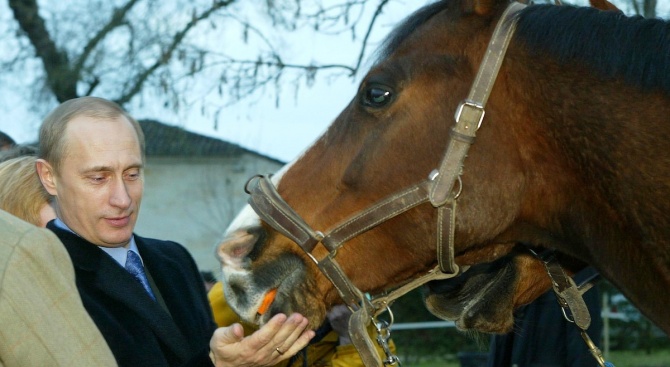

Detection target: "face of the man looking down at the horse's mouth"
[54, 116, 144, 247]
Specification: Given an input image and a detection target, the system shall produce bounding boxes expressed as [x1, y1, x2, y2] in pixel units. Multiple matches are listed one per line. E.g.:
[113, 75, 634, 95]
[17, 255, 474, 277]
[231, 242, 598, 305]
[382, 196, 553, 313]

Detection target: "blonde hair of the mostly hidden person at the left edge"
[0, 156, 51, 226]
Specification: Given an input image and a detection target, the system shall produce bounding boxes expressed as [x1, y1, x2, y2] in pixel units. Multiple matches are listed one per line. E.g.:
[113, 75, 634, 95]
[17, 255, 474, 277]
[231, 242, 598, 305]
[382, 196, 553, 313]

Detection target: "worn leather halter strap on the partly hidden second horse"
[528, 248, 614, 367]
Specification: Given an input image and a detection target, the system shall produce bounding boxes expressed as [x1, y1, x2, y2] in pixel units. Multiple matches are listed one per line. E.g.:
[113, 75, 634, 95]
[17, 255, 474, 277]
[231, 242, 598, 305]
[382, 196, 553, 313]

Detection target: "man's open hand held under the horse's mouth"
[209, 313, 314, 367]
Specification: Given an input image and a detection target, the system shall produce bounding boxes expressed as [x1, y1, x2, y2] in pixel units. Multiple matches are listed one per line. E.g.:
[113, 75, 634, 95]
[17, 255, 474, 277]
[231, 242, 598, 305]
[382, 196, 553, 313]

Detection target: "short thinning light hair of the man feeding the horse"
[39, 97, 145, 172]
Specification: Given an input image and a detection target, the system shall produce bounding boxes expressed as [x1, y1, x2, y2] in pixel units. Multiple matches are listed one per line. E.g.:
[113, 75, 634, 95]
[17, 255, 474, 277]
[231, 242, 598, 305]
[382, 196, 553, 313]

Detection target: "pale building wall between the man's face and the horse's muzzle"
[135, 154, 281, 276]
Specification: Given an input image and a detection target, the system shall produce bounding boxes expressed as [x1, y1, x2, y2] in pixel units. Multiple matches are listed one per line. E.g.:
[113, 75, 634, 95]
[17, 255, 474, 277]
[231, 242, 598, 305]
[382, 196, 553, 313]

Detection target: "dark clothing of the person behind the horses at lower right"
[488, 268, 603, 367]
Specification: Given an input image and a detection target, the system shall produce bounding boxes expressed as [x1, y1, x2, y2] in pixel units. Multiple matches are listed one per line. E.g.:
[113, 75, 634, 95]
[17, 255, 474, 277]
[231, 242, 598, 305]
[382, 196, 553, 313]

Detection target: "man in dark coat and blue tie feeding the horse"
[36, 97, 314, 367]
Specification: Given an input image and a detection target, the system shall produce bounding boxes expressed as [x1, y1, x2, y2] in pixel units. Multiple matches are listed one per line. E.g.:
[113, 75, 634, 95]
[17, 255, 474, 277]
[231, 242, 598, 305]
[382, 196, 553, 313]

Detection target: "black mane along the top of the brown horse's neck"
[513, 5, 670, 93]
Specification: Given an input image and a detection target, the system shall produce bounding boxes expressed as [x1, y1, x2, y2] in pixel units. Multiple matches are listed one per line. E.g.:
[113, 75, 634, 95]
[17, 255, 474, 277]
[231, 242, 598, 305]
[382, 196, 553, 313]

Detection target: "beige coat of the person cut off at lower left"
[0, 211, 116, 367]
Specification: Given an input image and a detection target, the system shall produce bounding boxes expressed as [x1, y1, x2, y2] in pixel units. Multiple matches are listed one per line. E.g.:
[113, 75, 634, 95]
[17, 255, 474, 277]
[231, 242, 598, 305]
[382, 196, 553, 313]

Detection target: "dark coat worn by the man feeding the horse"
[47, 221, 216, 367]
